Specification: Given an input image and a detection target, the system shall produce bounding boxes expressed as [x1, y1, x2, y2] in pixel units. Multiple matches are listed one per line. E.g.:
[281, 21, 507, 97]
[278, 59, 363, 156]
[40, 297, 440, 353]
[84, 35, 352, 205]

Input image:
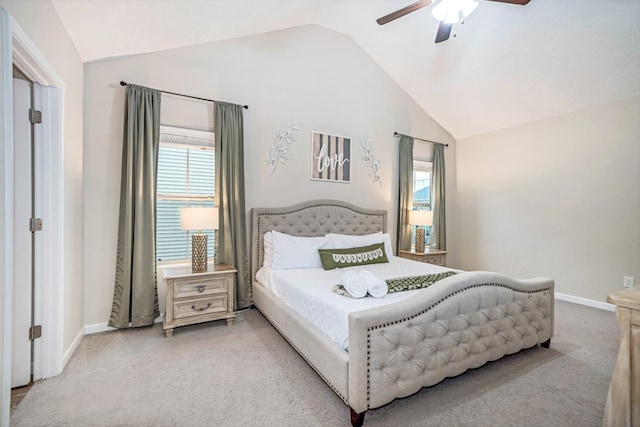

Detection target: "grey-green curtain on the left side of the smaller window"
[397, 135, 413, 251]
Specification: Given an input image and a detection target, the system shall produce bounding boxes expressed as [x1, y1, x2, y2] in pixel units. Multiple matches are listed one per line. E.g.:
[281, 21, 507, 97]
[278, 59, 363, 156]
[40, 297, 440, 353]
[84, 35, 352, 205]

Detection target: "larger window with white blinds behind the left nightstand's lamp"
[156, 126, 215, 261]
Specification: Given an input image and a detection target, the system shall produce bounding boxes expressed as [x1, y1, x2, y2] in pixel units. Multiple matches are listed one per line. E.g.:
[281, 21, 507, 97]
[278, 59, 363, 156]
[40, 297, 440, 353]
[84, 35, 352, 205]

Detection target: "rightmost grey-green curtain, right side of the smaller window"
[429, 144, 447, 250]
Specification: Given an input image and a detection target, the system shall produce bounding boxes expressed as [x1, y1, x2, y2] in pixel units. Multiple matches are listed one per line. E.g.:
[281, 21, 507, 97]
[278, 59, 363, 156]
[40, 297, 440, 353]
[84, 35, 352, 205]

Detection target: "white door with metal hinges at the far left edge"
[11, 79, 32, 388]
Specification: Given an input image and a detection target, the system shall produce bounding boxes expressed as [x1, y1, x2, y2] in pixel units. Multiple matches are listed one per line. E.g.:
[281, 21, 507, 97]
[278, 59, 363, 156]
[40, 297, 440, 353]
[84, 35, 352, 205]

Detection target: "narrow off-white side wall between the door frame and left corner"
[0, 0, 84, 422]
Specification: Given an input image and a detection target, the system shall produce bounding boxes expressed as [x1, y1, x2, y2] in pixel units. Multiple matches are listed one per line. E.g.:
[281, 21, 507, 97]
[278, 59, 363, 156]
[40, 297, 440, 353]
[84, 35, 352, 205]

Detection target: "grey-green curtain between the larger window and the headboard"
[214, 102, 251, 310]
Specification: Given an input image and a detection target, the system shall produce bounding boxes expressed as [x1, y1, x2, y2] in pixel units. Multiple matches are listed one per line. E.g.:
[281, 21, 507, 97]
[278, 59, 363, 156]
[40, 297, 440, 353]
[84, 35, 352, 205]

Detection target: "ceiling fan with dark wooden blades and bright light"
[376, 0, 530, 43]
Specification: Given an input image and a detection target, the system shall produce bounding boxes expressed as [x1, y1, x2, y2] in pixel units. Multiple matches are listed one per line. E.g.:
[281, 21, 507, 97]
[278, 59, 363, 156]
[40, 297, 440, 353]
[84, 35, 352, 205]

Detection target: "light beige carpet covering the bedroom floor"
[11, 301, 620, 427]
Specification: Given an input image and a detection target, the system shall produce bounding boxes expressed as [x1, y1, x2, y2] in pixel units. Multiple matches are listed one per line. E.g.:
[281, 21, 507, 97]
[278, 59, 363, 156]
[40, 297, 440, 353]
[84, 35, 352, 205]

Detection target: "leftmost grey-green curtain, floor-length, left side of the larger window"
[109, 84, 160, 328]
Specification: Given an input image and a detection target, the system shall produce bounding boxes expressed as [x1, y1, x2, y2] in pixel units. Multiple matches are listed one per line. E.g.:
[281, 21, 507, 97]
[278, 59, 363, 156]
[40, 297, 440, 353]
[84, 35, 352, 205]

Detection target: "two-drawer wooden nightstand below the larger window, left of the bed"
[162, 264, 236, 337]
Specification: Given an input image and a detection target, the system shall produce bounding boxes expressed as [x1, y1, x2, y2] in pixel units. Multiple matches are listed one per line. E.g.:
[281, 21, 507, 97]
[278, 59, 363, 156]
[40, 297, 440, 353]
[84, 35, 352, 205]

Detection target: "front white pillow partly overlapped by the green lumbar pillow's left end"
[271, 230, 329, 270]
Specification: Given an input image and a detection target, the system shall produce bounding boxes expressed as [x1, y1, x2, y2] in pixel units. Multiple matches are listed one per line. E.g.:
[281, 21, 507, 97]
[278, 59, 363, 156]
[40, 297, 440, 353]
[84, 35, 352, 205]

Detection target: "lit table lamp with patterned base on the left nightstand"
[180, 207, 218, 273]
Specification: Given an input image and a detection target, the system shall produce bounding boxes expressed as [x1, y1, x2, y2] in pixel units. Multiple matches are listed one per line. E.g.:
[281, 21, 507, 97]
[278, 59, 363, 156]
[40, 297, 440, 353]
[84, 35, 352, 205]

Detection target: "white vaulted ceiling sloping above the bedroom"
[51, 0, 640, 139]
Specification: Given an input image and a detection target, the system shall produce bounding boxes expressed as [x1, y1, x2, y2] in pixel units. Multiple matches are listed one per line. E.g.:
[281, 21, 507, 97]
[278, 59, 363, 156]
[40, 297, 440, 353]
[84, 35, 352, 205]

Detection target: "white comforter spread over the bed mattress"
[256, 256, 451, 351]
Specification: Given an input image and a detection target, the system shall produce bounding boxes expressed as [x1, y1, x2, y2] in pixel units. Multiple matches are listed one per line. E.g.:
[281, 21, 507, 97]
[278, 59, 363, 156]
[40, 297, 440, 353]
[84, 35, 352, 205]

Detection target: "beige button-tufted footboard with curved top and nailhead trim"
[348, 272, 554, 413]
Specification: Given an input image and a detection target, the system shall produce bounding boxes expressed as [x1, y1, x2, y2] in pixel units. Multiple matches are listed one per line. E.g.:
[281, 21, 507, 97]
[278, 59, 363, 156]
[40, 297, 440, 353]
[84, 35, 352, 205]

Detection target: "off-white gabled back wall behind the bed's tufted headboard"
[84, 26, 453, 324]
